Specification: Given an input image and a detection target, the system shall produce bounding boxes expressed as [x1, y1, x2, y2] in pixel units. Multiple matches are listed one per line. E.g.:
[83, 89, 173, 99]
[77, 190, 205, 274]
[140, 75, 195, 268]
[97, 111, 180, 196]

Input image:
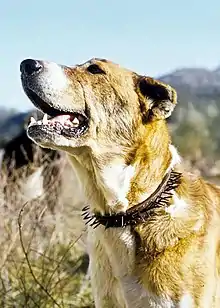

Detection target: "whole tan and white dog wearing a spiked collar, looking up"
[20, 58, 220, 308]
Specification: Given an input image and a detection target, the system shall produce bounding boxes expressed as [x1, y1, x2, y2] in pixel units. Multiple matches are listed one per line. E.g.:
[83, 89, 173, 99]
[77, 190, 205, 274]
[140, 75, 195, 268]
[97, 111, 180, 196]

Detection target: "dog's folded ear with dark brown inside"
[138, 77, 177, 119]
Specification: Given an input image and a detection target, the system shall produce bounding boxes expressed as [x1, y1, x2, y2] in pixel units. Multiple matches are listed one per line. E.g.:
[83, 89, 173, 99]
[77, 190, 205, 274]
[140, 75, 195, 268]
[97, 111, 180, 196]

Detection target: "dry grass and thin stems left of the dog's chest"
[0, 152, 94, 308]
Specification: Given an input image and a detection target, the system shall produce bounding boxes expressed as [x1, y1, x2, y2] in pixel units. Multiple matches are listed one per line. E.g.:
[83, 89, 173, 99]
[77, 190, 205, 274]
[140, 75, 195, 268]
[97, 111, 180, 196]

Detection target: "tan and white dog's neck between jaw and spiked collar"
[70, 121, 179, 214]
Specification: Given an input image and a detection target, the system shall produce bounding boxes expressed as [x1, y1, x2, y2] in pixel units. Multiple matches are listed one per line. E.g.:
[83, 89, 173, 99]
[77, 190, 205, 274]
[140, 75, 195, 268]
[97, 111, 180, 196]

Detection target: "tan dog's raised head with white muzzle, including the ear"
[20, 59, 177, 153]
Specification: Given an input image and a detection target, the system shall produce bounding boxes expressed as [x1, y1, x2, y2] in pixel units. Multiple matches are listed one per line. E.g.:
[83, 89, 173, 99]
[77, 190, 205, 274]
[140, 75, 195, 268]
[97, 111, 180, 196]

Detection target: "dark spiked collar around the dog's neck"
[82, 170, 181, 229]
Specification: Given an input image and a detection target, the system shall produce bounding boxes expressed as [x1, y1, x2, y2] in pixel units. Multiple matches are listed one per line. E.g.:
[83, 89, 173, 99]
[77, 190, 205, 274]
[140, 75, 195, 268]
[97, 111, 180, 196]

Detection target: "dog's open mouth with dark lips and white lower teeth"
[25, 89, 89, 138]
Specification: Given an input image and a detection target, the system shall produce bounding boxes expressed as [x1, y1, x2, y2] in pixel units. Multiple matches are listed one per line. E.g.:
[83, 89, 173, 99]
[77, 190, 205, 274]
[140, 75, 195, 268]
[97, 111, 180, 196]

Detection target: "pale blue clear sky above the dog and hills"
[0, 0, 220, 110]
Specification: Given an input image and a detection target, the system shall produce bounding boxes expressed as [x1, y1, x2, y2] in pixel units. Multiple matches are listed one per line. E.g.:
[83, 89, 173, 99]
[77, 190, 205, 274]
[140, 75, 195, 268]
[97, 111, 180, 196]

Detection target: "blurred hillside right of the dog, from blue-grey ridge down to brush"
[162, 67, 220, 181]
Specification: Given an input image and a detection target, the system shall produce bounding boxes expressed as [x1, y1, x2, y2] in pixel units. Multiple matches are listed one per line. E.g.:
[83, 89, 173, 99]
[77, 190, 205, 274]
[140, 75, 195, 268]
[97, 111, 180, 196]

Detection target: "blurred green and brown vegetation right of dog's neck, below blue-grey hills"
[169, 100, 220, 178]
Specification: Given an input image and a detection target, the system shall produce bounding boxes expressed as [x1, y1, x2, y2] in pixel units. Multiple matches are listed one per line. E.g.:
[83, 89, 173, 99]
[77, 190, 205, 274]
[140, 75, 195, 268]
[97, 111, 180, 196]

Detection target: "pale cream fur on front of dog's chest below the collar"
[88, 227, 176, 308]
